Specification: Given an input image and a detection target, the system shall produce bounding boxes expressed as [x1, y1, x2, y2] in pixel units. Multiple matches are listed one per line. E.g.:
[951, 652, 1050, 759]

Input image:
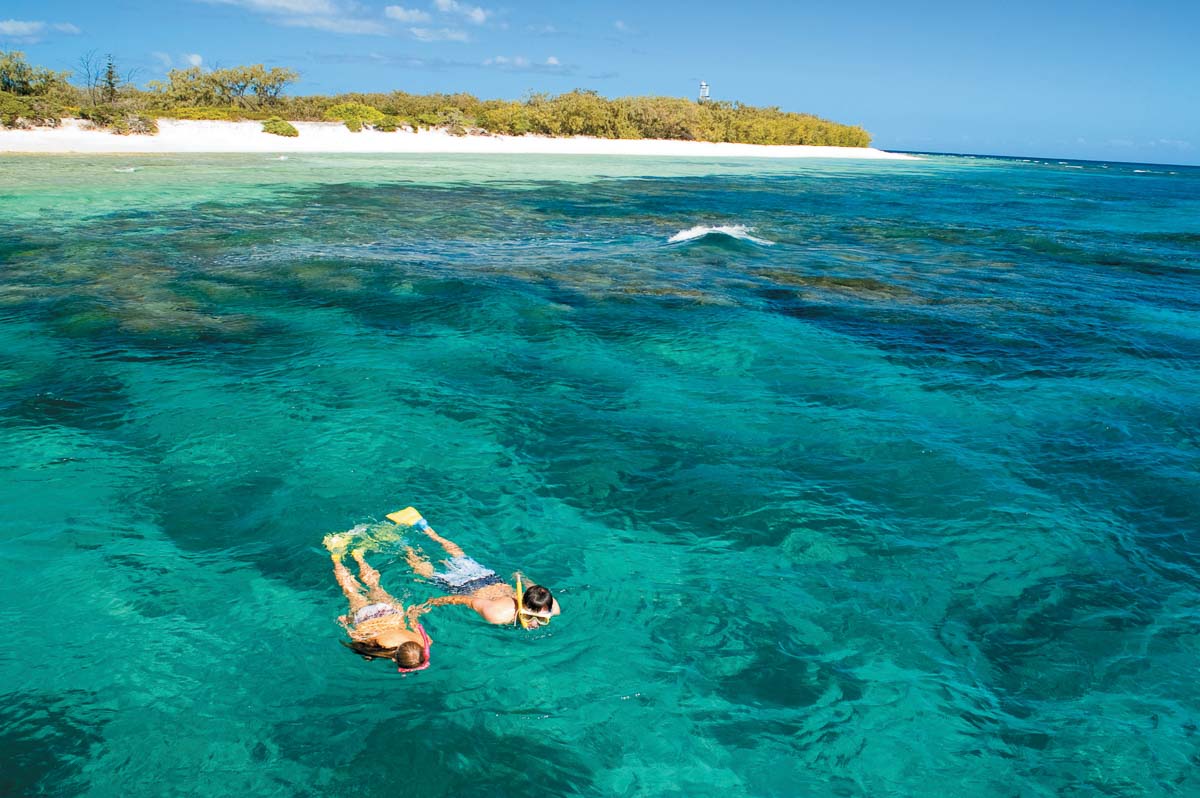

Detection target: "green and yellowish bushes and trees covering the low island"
[0, 50, 871, 146]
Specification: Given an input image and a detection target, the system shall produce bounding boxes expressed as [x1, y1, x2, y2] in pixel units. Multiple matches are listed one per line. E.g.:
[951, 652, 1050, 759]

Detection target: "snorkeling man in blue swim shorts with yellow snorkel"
[388, 508, 562, 629]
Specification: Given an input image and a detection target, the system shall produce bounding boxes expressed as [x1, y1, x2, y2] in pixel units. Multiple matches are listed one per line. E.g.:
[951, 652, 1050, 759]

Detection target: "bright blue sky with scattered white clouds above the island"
[0, 0, 1200, 163]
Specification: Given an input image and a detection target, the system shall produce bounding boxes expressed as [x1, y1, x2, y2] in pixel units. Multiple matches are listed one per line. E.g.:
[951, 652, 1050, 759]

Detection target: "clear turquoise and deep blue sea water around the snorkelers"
[0, 156, 1200, 797]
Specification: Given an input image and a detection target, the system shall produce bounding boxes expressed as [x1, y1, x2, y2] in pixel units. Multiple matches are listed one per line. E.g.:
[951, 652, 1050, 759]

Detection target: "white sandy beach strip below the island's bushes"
[0, 119, 913, 160]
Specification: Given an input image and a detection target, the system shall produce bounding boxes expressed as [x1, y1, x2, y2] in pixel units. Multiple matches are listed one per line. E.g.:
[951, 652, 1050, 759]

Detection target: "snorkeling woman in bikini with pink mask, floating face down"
[324, 534, 433, 673]
